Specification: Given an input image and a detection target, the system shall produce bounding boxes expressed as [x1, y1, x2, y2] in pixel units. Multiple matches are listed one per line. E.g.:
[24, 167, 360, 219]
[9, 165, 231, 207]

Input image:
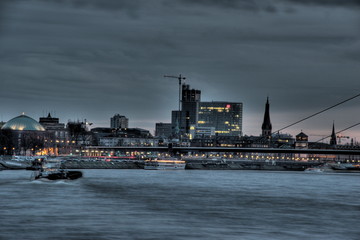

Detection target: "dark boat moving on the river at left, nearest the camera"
[31, 162, 82, 180]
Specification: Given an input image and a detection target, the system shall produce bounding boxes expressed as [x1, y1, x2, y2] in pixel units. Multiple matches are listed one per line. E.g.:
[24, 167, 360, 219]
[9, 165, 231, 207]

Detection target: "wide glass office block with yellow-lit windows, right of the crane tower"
[198, 102, 243, 136]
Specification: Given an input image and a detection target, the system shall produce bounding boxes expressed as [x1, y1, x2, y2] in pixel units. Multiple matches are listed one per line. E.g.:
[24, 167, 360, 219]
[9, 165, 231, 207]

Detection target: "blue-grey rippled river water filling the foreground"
[0, 170, 360, 240]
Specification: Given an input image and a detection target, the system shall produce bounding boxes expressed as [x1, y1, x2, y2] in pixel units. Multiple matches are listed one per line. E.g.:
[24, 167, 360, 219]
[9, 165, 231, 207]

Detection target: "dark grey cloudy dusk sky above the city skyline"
[0, 0, 360, 141]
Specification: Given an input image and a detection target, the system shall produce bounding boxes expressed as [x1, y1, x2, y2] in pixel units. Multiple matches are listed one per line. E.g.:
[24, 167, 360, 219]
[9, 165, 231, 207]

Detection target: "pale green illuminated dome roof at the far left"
[1, 115, 45, 131]
